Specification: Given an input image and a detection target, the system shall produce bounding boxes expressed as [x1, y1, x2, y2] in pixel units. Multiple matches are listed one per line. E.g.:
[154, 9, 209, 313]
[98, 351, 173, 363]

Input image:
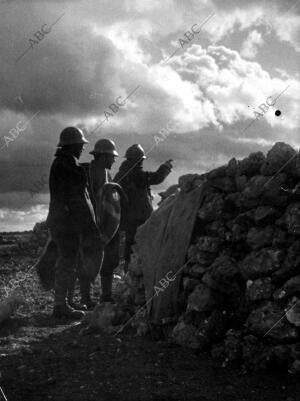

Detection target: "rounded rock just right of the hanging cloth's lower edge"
[187, 283, 216, 312]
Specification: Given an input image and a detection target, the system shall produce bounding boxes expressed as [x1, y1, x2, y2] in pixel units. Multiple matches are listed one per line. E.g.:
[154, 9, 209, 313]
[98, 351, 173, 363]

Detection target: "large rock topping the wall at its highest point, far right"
[261, 142, 296, 175]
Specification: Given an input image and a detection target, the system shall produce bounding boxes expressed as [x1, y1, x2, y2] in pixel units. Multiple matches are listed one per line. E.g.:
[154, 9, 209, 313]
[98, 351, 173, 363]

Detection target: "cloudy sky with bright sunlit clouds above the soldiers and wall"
[0, 0, 300, 231]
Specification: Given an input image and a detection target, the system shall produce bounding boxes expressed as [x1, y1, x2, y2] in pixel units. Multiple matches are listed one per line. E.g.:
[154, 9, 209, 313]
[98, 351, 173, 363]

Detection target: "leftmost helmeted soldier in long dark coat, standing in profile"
[47, 127, 98, 319]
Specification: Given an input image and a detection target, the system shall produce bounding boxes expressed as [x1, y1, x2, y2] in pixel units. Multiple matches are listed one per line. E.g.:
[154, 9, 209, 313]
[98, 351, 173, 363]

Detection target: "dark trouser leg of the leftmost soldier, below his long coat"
[52, 228, 79, 305]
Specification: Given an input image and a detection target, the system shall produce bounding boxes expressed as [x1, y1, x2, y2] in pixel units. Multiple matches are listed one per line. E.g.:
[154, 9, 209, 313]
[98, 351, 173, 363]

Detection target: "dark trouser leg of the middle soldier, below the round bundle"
[100, 233, 120, 301]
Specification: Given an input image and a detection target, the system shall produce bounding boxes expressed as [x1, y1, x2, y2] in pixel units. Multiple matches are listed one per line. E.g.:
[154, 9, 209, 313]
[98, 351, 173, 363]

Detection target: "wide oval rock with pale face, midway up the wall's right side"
[240, 248, 284, 280]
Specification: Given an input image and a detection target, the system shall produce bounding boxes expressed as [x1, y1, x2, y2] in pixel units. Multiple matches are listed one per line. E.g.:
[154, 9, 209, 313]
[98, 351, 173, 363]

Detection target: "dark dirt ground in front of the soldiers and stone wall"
[0, 257, 300, 401]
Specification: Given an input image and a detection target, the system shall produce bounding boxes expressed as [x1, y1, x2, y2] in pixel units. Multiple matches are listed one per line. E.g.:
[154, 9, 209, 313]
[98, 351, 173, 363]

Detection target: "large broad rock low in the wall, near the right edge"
[246, 302, 298, 343]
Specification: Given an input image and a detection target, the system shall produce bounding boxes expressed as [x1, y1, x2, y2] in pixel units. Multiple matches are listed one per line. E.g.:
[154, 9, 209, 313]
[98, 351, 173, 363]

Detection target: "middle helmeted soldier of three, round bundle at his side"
[90, 139, 120, 302]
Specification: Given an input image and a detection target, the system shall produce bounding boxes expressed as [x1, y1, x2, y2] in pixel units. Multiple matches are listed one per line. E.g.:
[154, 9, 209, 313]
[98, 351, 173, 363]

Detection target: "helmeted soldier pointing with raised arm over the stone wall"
[114, 144, 172, 272]
